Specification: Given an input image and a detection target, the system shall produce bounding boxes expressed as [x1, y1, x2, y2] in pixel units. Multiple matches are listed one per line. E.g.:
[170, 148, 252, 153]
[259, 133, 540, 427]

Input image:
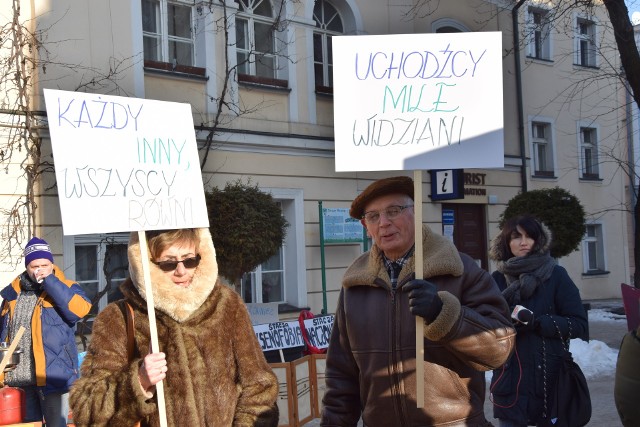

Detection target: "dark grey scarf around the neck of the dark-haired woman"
[497, 252, 556, 306]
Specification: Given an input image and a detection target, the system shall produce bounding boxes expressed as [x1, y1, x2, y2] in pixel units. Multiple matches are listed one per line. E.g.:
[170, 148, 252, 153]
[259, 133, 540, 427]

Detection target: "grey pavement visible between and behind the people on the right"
[302, 299, 627, 427]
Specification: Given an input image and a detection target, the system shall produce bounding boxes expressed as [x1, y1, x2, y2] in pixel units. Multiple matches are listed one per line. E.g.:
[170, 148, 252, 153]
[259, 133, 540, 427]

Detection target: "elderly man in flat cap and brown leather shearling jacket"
[321, 176, 515, 427]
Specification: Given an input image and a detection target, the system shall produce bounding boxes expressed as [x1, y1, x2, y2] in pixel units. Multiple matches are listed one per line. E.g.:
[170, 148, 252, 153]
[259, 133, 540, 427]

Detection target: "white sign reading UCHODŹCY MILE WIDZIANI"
[332, 32, 504, 172]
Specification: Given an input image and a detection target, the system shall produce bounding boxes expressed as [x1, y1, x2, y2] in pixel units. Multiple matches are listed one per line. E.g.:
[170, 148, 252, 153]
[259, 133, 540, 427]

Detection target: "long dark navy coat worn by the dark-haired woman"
[491, 265, 589, 425]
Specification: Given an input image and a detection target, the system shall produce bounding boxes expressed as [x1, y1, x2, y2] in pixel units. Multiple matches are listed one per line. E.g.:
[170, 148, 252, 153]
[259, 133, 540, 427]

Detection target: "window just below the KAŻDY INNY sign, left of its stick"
[64, 233, 129, 328]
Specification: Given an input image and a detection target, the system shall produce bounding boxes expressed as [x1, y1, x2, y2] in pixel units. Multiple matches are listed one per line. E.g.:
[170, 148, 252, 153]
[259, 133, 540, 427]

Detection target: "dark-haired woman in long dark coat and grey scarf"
[490, 215, 589, 427]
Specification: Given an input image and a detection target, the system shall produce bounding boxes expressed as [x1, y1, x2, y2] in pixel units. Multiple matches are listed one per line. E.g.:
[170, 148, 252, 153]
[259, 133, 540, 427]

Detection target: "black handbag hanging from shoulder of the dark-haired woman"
[540, 318, 591, 427]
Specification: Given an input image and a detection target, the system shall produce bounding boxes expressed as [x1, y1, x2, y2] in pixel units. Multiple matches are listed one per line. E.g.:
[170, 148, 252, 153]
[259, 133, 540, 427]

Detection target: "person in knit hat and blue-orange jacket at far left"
[0, 237, 91, 427]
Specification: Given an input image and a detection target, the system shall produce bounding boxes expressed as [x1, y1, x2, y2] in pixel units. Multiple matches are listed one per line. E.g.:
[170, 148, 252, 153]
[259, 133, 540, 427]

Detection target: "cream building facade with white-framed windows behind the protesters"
[0, 0, 632, 317]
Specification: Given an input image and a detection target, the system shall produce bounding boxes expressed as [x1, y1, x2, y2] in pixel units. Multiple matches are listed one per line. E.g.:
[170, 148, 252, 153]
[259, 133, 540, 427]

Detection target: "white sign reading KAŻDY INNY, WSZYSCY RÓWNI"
[44, 89, 209, 235]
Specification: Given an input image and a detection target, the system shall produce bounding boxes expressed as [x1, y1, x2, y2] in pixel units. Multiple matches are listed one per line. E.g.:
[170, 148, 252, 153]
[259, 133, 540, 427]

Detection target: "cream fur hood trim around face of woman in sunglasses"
[127, 228, 218, 322]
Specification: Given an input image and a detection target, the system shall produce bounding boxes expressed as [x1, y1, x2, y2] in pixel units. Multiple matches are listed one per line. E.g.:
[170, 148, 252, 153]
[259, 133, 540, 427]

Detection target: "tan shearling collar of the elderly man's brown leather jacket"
[343, 225, 464, 288]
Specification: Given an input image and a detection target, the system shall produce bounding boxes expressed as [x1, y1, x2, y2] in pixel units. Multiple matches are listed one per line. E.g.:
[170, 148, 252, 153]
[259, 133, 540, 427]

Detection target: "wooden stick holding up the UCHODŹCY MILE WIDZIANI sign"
[413, 170, 424, 408]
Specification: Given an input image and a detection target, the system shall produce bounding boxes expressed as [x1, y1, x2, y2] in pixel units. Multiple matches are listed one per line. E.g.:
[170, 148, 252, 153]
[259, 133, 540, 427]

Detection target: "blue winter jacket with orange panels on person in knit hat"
[0, 265, 91, 394]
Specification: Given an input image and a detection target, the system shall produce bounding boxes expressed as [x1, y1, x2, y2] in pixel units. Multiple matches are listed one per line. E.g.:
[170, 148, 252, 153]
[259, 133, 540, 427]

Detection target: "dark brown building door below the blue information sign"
[442, 204, 489, 271]
